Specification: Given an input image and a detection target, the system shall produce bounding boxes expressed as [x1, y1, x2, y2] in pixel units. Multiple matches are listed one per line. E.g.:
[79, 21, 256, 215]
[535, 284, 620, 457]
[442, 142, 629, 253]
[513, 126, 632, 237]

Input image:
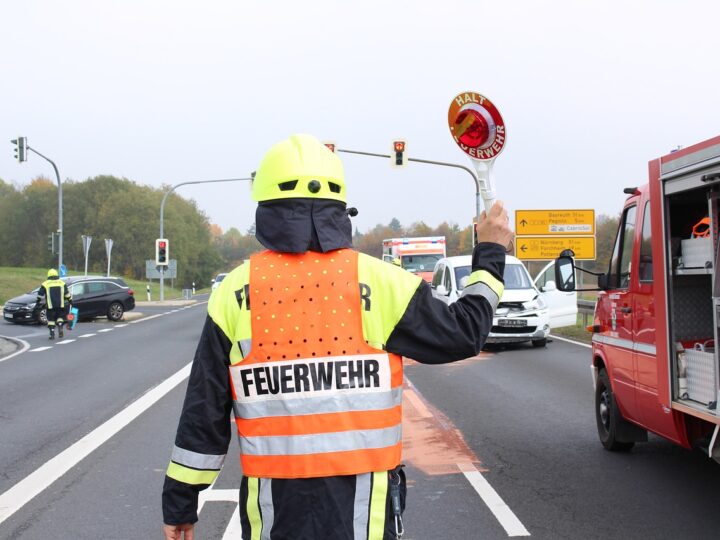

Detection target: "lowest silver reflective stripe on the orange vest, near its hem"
[240, 426, 402, 456]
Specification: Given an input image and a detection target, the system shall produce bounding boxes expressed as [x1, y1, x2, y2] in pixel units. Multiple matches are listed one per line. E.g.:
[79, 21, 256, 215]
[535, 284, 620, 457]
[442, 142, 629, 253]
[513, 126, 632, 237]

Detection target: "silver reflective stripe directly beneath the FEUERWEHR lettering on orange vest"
[233, 386, 402, 420]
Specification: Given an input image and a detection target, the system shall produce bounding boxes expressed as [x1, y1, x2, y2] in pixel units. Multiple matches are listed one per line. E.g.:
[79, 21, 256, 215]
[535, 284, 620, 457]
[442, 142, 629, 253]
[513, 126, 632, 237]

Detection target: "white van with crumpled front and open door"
[431, 255, 577, 347]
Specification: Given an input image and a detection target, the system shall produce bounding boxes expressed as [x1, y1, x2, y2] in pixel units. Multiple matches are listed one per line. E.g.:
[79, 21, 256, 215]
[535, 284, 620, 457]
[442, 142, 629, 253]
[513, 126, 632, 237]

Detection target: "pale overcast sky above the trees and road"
[0, 0, 720, 235]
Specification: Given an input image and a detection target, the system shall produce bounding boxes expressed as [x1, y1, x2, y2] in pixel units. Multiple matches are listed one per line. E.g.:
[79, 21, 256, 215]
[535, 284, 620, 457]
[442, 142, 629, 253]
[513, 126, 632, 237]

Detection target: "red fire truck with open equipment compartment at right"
[556, 137, 720, 461]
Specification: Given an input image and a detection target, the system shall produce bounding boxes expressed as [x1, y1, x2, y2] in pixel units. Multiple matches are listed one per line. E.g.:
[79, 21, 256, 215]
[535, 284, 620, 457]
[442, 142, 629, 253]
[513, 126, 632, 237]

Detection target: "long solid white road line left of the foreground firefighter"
[0, 363, 192, 523]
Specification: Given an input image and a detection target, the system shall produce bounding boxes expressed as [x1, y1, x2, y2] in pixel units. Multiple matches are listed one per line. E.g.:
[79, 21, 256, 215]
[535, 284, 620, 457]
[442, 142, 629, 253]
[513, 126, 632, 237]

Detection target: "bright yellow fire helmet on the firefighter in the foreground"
[252, 134, 346, 202]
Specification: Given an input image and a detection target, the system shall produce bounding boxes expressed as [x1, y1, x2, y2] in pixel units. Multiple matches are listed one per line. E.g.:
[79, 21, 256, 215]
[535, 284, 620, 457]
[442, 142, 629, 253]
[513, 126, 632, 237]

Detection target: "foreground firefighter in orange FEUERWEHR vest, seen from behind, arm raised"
[162, 135, 512, 540]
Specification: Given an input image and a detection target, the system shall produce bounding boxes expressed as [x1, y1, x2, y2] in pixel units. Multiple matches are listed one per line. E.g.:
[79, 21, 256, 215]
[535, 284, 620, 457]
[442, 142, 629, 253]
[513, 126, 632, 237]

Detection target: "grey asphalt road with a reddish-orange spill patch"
[0, 304, 720, 540]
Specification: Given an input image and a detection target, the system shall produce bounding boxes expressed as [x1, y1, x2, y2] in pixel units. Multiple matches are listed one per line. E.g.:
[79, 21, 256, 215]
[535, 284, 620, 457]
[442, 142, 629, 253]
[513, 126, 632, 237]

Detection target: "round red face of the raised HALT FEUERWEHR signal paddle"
[448, 92, 506, 161]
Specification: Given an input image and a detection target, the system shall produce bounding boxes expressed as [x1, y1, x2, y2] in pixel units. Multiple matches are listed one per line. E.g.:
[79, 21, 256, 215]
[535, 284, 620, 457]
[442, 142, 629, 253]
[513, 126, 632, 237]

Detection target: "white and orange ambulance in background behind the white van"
[383, 236, 446, 283]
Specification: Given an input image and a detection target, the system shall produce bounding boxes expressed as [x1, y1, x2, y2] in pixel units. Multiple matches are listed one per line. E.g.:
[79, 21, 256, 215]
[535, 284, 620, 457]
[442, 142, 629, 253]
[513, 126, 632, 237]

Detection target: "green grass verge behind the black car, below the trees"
[0, 266, 210, 305]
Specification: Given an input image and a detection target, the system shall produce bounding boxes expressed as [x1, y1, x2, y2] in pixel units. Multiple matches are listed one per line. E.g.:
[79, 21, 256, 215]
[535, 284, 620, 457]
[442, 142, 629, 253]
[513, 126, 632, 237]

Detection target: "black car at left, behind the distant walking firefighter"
[3, 276, 135, 324]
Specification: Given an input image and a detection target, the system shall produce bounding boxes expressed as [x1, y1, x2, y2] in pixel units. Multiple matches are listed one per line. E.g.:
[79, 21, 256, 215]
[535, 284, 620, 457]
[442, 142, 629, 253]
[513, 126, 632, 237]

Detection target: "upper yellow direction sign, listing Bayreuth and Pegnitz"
[515, 210, 595, 236]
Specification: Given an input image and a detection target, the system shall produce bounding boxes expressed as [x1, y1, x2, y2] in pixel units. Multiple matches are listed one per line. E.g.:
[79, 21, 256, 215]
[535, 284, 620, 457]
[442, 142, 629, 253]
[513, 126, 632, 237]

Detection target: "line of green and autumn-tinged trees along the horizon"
[0, 175, 618, 286]
